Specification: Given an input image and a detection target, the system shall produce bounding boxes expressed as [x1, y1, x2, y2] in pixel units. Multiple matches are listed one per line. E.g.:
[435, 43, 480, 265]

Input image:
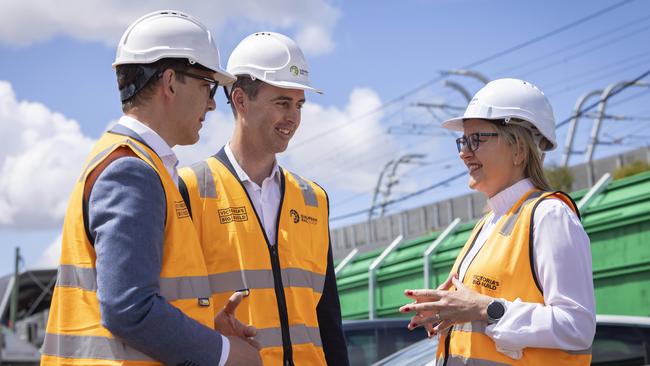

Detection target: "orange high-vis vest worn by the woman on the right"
[437, 189, 591, 366]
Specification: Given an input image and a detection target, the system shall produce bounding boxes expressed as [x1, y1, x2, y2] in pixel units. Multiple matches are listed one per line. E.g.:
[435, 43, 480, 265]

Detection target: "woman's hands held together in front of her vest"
[399, 273, 493, 336]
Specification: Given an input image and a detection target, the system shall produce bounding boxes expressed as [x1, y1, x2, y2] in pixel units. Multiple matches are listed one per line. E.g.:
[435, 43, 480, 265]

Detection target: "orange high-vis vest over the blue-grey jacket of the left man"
[41, 132, 215, 365]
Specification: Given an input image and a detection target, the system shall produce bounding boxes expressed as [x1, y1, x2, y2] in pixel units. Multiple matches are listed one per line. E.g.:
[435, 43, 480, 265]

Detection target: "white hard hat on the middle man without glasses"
[226, 32, 322, 94]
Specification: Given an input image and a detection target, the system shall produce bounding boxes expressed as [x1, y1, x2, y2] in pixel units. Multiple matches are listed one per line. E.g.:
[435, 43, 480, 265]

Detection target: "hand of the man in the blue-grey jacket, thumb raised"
[214, 291, 262, 366]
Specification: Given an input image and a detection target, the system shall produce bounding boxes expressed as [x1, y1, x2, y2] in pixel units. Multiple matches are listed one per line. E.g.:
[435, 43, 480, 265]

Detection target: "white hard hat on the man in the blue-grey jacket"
[113, 10, 235, 85]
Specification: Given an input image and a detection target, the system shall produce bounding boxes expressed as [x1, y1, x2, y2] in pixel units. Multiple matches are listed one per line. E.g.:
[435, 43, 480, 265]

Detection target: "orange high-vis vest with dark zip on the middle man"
[179, 150, 329, 365]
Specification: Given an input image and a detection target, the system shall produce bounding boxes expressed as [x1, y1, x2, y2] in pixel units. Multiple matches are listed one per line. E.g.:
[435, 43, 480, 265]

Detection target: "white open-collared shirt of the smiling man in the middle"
[224, 142, 281, 245]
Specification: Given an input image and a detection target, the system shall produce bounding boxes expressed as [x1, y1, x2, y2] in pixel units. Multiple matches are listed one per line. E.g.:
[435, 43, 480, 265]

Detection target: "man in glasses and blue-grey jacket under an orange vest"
[41, 11, 261, 365]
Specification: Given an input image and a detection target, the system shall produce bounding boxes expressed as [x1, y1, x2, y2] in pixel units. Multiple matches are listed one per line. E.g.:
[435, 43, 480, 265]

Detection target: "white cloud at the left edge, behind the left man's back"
[0, 81, 93, 228]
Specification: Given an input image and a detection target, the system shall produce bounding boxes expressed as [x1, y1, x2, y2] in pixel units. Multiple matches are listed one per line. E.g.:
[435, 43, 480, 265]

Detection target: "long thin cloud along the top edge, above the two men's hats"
[0, 0, 340, 54]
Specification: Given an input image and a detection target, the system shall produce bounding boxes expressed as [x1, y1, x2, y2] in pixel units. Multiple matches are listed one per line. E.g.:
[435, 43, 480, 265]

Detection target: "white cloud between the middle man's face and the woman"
[280, 88, 402, 192]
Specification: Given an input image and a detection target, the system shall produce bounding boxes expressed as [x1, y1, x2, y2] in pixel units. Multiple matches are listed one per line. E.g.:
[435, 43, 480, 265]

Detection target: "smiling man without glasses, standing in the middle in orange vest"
[180, 32, 349, 366]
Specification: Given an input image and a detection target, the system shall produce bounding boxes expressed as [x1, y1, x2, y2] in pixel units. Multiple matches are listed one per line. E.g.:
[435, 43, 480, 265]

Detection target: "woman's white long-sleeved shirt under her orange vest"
[459, 179, 596, 358]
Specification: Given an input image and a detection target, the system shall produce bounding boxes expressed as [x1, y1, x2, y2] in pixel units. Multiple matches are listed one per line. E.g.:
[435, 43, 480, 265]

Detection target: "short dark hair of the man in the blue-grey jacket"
[115, 58, 191, 112]
